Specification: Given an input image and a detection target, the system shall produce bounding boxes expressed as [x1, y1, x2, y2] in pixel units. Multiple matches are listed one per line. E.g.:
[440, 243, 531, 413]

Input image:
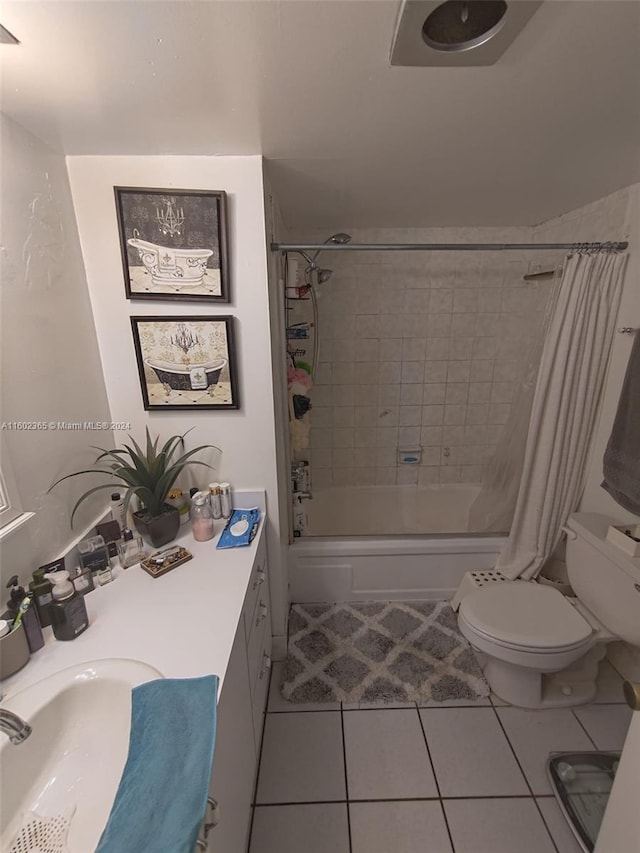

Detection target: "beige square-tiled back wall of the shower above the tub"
[292, 228, 550, 489]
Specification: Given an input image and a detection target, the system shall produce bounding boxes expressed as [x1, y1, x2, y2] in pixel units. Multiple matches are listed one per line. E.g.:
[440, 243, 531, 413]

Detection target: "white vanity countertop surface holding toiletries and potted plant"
[2, 492, 265, 699]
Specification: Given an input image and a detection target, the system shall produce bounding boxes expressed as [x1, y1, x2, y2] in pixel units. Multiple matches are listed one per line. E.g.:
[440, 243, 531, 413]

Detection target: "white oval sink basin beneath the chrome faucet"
[0, 659, 162, 853]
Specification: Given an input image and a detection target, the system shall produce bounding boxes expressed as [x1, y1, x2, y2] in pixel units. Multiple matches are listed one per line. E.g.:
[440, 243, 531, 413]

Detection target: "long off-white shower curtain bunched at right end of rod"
[496, 253, 627, 580]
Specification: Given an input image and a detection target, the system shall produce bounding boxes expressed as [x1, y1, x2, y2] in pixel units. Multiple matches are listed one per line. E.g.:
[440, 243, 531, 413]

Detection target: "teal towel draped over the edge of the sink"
[96, 675, 219, 853]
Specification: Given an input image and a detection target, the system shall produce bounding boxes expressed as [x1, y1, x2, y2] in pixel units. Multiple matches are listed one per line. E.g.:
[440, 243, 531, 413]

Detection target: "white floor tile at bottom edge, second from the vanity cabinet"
[349, 801, 452, 853]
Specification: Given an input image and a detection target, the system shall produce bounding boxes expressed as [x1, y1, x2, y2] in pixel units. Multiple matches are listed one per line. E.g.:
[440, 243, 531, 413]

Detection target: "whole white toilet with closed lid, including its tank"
[458, 513, 640, 708]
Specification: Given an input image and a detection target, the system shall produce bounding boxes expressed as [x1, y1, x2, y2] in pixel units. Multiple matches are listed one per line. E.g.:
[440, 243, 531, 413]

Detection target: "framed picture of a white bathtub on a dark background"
[114, 187, 229, 302]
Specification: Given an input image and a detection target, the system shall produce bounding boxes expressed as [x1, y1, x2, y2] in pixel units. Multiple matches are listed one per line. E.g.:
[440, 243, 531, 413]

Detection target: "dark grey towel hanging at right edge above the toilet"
[602, 332, 640, 515]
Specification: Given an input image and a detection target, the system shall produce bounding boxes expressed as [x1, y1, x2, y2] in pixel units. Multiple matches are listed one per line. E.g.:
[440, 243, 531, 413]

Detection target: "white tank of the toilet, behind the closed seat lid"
[566, 512, 640, 646]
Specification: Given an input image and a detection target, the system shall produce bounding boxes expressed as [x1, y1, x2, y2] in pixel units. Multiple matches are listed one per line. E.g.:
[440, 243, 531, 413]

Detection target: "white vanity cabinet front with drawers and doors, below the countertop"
[202, 537, 271, 853]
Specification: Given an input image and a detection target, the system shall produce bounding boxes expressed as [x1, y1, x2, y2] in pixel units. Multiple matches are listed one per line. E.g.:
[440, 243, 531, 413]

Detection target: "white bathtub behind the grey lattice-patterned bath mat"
[288, 484, 506, 602]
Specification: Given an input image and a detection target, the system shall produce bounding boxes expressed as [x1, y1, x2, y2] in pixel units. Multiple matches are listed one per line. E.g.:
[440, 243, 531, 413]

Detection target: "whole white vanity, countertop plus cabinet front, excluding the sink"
[2, 492, 271, 853]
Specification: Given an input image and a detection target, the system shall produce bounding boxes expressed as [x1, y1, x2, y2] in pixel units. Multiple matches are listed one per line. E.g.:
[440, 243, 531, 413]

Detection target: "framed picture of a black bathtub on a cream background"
[131, 315, 240, 411]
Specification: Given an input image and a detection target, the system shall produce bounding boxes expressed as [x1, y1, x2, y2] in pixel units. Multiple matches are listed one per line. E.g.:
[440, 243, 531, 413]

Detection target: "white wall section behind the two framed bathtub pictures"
[67, 156, 285, 635]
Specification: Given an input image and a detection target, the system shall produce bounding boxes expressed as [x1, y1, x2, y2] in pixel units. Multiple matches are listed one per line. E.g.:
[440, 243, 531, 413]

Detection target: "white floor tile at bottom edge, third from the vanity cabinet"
[444, 797, 555, 853]
